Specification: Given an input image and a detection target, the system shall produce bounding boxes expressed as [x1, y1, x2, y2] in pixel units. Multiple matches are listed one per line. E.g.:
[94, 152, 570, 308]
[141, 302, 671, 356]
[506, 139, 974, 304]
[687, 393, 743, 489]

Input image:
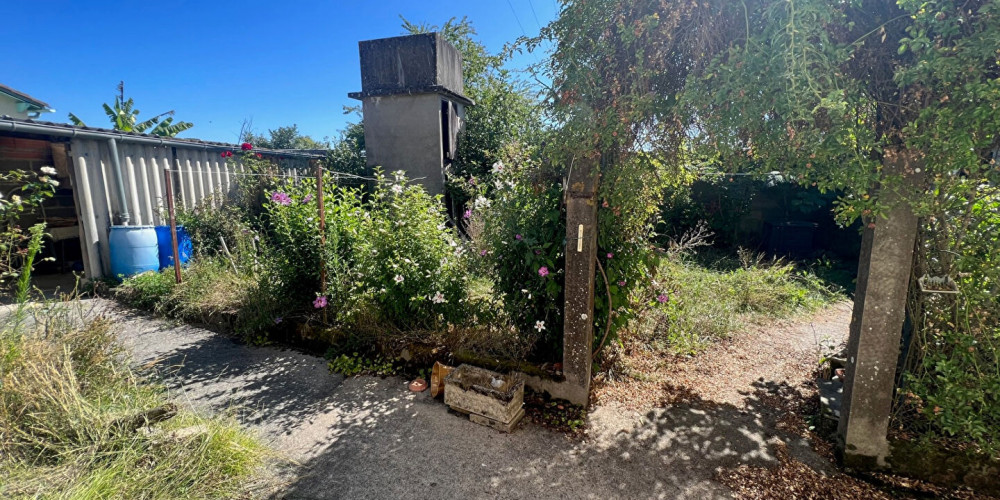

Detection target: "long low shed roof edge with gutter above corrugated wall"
[0, 118, 326, 158]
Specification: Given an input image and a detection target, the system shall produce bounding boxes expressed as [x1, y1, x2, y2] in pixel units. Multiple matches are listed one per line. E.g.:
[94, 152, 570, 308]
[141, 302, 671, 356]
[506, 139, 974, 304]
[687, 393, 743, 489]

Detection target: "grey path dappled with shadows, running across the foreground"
[94, 301, 847, 499]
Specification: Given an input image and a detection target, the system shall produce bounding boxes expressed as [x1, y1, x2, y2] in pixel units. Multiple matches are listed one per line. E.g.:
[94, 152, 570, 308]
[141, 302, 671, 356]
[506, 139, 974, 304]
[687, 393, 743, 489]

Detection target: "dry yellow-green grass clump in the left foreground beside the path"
[0, 303, 266, 499]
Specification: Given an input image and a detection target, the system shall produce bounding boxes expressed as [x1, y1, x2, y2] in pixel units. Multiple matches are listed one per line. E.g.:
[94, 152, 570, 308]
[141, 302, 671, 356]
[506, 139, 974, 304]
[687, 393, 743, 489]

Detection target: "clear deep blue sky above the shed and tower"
[0, 0, 557, 142]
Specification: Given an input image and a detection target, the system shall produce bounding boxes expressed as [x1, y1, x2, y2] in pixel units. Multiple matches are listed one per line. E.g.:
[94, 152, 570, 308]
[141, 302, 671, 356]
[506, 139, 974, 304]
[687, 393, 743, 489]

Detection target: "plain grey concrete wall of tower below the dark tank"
[362, 94, 444, 194]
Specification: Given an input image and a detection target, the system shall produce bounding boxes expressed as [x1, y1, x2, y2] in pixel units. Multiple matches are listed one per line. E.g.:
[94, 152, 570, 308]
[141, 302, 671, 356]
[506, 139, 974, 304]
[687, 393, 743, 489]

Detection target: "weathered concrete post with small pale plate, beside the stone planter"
[562, 158, 598, 405]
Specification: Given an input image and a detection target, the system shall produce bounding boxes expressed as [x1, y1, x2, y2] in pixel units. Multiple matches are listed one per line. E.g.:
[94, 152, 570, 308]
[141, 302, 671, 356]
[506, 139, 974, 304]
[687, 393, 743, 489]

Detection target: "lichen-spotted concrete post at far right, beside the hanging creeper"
[837, 150, 920, 469]
